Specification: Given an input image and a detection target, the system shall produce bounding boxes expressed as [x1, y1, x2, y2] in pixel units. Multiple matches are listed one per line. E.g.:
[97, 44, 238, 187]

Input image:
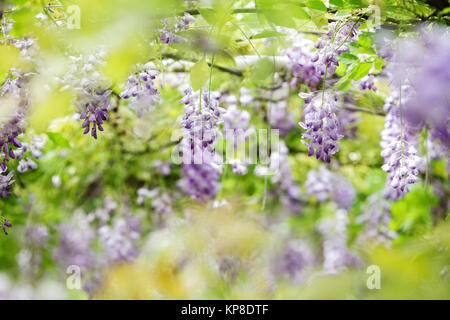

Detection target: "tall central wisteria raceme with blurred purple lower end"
[179, 89, 225, 201]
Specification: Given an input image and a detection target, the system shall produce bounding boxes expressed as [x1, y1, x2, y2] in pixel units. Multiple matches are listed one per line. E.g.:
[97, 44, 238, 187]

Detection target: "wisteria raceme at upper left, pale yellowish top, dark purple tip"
[58, 50, 112, 139]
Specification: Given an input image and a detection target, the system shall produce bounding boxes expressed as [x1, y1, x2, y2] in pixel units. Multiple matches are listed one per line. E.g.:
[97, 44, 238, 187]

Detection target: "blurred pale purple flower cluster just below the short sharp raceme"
[305, 165, 356, 210]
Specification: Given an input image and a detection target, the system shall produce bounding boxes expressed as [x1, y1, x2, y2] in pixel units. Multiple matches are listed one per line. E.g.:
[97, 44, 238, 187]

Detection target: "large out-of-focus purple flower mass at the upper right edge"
[388, 26, 450, 149]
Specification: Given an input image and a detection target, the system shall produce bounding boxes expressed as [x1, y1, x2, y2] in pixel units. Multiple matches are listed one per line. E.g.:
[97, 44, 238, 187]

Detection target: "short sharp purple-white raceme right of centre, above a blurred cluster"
[299, 92, 343, 163]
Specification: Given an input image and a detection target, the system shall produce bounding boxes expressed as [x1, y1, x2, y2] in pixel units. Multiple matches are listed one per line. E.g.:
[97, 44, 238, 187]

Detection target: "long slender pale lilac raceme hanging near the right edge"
[380, 87, 420, 200]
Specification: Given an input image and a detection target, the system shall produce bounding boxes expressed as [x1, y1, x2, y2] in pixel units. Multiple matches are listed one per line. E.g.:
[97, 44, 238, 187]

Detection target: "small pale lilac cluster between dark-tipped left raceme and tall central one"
[120, 66, 159, 117]
